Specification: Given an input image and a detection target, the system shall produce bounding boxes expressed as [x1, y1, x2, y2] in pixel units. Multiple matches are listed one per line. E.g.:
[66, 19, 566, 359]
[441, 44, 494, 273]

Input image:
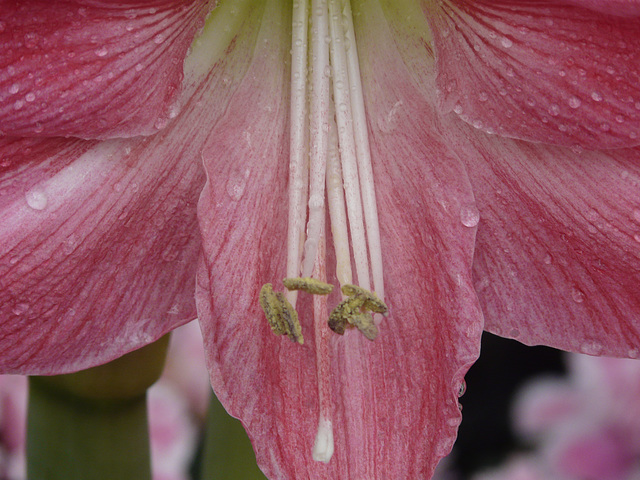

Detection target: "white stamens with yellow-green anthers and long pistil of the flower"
[260, 0, 387, 462]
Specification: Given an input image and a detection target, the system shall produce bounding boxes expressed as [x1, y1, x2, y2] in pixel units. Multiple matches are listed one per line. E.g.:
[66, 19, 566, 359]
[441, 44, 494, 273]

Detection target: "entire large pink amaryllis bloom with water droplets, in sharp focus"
[0, 0, 640, 478]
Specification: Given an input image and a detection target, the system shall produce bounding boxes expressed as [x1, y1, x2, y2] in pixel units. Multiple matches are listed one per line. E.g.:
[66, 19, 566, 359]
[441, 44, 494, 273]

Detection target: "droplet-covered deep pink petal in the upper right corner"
[425, 0, 640, 148]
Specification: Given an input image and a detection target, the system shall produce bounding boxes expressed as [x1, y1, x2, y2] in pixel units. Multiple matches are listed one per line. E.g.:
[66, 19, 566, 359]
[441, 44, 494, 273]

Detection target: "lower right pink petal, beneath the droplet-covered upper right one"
[450, 118, 640, 358]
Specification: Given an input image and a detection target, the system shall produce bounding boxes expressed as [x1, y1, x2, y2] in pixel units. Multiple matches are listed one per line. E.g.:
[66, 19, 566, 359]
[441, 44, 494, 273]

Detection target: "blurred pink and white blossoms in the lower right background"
[514, 354, 640, 480]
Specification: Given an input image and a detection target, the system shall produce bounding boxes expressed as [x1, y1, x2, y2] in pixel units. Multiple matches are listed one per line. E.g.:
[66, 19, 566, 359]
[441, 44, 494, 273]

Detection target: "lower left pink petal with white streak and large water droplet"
[0, 129, 204, 374]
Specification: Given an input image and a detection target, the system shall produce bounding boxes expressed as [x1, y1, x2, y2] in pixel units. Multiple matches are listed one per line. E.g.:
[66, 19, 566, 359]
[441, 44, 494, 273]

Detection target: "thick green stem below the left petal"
[27, 338, 168, 480]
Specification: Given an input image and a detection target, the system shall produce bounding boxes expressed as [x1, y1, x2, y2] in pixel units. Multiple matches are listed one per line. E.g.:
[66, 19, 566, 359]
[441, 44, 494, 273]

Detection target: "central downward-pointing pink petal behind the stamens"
[197, 1, 481, 478]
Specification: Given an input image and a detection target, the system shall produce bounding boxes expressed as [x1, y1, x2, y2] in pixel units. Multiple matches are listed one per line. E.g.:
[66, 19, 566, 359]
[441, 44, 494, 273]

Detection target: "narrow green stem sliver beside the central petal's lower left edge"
[201, 394, 267, 480]
